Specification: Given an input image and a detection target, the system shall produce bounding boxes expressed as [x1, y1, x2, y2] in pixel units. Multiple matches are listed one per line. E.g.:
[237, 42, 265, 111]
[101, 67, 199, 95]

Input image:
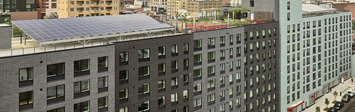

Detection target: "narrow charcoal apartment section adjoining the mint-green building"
[243, 22, 280, 112]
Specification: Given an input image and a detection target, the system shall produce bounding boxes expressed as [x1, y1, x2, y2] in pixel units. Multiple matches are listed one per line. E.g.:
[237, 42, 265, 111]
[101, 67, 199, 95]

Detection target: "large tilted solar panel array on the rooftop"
[12, 14, 172, 41]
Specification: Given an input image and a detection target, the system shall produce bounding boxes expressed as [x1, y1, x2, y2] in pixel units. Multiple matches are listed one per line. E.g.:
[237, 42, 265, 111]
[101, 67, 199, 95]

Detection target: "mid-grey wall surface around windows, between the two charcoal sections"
[193, 27, 244, 112]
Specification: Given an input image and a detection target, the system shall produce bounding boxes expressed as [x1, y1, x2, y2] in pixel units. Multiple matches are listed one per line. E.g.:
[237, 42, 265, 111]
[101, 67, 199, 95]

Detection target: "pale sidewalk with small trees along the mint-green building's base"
[303, 78, 355, 112]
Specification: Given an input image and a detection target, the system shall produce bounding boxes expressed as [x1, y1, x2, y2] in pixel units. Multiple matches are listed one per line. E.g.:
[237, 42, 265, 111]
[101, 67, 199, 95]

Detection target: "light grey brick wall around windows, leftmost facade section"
[0, 45, 115, 112]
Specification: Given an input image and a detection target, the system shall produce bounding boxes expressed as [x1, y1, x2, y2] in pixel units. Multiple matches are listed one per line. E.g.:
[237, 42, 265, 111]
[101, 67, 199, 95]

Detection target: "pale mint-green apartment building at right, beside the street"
[279, 1, 351, 112]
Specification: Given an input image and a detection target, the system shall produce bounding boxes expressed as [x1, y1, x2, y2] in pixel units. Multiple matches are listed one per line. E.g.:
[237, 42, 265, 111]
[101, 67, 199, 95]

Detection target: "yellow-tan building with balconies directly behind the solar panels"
[58, 0, 120, 18]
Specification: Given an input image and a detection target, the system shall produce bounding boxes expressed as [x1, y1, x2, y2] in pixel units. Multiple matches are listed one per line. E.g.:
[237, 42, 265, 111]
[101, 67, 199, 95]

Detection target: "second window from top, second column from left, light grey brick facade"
[47, 84, 65, 100]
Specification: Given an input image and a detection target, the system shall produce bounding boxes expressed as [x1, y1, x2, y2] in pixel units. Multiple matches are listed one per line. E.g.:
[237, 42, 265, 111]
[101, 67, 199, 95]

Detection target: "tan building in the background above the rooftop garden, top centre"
[167, 0, 222, 16]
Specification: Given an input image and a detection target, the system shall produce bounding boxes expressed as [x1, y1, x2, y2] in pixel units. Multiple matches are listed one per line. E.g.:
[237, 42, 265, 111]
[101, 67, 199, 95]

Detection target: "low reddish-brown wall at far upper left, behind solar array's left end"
[9, 11, 38, 21]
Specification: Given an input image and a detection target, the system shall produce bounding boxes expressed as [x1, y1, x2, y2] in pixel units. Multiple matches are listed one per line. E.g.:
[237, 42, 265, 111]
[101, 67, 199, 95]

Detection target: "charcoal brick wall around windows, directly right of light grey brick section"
[115, 34, 193, 112]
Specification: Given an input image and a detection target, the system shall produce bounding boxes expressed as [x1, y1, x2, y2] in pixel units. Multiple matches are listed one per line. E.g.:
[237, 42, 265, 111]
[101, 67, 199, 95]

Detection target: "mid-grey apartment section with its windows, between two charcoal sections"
[193, 27, 244, 112]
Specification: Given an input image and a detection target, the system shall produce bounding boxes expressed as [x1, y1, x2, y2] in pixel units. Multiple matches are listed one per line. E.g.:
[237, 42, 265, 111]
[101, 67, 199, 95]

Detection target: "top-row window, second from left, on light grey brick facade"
[47, 63, 65, 77]
